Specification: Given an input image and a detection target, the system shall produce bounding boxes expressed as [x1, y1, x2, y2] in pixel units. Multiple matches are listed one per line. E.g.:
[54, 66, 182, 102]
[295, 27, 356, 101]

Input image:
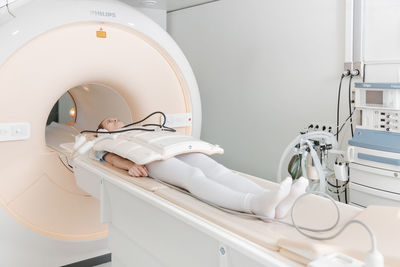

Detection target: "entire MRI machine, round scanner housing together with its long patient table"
[0, 0, 400, 267]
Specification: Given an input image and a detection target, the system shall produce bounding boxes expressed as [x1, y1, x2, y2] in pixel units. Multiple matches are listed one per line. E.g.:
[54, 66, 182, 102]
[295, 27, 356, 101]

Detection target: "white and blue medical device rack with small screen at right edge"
[347, 83, 400, 207]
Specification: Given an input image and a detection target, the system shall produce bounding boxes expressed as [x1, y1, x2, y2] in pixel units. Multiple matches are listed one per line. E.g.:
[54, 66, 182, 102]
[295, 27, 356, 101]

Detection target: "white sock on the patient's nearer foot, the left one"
[250, 177, 292, 222]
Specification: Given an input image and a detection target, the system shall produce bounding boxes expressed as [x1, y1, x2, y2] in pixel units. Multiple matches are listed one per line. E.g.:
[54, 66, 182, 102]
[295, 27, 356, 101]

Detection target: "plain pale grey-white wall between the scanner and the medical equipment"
[167, 0, 347, 180]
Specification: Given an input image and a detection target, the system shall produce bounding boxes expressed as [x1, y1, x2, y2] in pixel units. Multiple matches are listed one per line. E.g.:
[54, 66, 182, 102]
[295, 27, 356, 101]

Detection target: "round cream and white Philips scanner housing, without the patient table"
[0, 0, 201, 266]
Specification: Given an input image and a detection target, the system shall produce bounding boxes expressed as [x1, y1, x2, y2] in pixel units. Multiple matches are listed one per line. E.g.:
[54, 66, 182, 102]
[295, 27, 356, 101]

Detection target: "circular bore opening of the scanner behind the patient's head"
[45, 84, 132, 171]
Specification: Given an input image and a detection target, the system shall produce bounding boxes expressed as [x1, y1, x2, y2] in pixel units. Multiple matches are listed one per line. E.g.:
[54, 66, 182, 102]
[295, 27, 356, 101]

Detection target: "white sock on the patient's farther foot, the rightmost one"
[275, 177, 308, 219]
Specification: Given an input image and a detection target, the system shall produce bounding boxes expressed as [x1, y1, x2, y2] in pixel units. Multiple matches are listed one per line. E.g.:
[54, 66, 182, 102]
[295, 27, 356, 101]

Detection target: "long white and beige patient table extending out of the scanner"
[75, 157, 400, 266]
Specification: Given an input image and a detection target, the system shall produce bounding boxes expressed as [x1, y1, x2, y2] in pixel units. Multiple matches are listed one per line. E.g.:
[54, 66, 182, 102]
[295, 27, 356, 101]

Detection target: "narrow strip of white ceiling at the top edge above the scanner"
[119, 0, 219, 11]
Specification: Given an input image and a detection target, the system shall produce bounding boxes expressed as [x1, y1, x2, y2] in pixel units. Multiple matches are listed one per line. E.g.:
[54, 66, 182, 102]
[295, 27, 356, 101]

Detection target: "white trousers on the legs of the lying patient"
[146, 153, 267, 212]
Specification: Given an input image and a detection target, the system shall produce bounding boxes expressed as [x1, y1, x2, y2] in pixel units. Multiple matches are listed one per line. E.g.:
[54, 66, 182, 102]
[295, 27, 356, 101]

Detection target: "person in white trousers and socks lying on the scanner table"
[95, 118, 308, 219]
